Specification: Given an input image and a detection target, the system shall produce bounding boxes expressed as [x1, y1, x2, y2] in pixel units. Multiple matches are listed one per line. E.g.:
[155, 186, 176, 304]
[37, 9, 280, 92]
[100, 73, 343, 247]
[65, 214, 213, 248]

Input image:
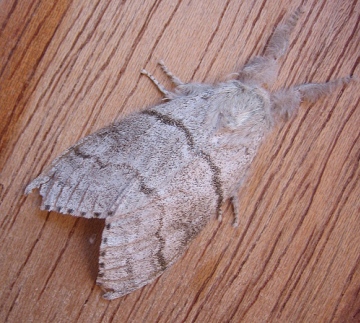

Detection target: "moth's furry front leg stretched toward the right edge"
[271, 76, 353, 120]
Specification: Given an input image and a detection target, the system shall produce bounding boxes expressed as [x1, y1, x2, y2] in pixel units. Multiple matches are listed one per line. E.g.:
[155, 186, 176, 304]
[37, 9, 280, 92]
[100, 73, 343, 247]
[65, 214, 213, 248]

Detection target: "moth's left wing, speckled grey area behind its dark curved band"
[26, 114, 198, 218]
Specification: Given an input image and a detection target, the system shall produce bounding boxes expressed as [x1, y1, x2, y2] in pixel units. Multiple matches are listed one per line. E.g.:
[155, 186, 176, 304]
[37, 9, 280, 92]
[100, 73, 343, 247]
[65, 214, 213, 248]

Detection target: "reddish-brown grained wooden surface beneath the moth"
[0, 0, 360, 322]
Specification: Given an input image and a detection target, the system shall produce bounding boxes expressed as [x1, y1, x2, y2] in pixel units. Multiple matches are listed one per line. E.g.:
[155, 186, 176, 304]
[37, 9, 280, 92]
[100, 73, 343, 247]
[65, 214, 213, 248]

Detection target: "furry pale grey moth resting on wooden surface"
[25, 8, 350, 300]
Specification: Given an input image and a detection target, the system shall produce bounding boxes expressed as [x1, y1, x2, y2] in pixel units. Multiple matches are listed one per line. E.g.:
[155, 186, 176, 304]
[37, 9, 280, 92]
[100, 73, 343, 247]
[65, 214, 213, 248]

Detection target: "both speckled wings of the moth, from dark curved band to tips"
[26, 99, 222, 299]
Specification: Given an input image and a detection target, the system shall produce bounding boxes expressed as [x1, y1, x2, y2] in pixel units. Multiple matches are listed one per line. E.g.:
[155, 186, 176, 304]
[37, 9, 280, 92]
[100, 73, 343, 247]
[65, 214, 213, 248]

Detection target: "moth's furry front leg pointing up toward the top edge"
[238, 7, 303, 84]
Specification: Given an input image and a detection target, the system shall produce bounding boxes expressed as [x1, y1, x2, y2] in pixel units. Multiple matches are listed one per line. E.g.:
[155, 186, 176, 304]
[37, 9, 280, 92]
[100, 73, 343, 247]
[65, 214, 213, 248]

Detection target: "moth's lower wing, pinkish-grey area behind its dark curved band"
[97, 158, 217, 299]
